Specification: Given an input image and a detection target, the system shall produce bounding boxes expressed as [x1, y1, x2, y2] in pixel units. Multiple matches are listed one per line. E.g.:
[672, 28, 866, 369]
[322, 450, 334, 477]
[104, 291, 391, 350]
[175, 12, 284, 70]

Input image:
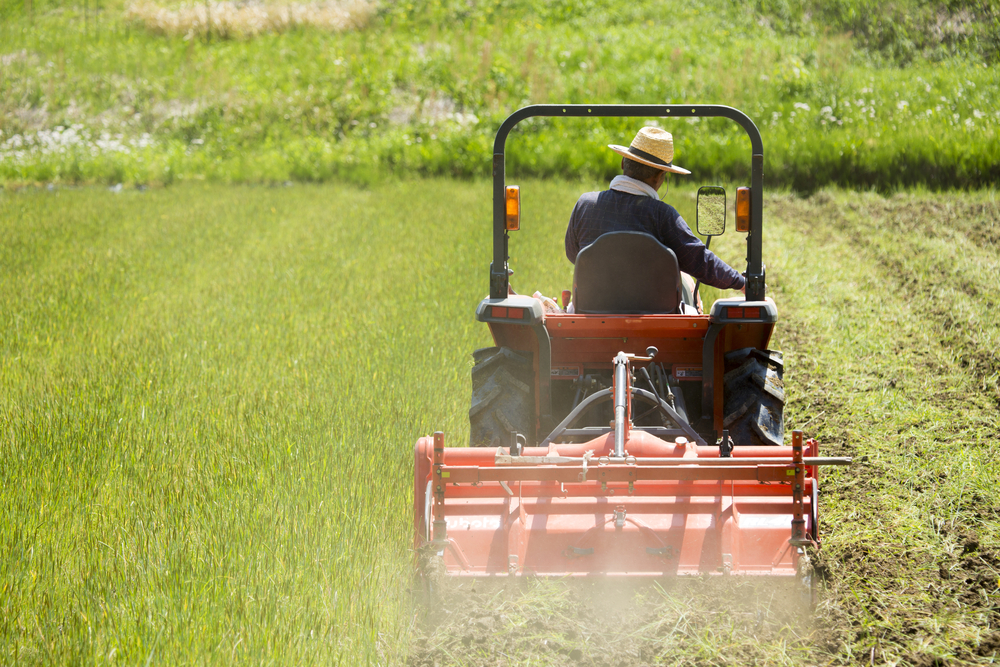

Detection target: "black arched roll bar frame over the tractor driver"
[490, 104, 764, 301]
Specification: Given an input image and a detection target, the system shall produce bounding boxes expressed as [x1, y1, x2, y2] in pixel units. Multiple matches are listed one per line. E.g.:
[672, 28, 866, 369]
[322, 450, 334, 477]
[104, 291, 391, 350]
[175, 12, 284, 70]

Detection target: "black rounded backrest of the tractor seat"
[573, 232, 681, 314]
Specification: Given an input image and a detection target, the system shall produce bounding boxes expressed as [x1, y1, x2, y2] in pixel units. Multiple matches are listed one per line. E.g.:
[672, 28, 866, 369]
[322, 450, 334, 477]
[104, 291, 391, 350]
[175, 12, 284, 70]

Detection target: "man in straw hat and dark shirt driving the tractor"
[566, 127, 746, 310]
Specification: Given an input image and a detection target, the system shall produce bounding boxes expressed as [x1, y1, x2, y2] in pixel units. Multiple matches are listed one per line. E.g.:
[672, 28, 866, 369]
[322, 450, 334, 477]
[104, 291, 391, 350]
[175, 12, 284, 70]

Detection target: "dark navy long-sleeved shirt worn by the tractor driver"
[566, 190, 746, 290]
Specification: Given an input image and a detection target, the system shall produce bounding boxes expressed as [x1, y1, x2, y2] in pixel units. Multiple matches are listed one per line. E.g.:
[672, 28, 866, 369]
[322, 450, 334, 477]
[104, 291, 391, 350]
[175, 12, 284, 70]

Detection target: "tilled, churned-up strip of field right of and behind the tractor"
[410, 193, 1000, 665]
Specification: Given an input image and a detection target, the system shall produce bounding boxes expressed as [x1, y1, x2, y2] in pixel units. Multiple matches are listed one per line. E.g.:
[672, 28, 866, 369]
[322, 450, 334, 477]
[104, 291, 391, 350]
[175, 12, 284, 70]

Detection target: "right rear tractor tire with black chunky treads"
[722, 347, 785, 446]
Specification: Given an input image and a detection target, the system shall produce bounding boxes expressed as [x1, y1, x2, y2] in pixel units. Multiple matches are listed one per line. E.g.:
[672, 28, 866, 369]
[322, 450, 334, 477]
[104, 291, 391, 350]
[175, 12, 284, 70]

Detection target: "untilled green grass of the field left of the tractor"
[0, 183, 500, 664]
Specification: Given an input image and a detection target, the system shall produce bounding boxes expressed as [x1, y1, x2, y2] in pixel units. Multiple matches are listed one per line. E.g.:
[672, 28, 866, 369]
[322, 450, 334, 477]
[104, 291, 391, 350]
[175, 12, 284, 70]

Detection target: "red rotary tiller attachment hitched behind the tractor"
[414, 348, 851, 576]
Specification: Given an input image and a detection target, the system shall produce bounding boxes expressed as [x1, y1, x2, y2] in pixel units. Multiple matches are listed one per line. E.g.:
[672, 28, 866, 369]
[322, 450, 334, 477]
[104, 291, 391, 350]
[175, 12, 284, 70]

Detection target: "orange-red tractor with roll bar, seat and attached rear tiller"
[414, 105, 850, 578]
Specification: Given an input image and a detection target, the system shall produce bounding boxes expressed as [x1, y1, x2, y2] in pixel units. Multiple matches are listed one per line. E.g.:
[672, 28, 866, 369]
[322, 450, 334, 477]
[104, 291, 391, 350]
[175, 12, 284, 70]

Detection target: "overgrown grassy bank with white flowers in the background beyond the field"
[0, 0, 1000, 190]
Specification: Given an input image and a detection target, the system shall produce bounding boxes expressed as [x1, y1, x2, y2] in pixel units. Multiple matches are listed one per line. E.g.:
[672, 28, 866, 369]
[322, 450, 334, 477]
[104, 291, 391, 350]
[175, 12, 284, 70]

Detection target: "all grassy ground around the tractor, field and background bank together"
[0, 0, 1000, 667]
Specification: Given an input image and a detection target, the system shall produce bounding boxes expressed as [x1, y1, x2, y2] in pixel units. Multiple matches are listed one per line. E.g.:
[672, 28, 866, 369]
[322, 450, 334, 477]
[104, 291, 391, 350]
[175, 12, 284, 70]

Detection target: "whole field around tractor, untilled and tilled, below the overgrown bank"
[0, 180, 1000, 665]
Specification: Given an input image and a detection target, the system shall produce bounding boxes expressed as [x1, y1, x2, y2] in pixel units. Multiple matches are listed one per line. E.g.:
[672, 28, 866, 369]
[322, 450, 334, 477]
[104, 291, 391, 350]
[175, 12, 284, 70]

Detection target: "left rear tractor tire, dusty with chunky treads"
[469, 347, 535, 447]
